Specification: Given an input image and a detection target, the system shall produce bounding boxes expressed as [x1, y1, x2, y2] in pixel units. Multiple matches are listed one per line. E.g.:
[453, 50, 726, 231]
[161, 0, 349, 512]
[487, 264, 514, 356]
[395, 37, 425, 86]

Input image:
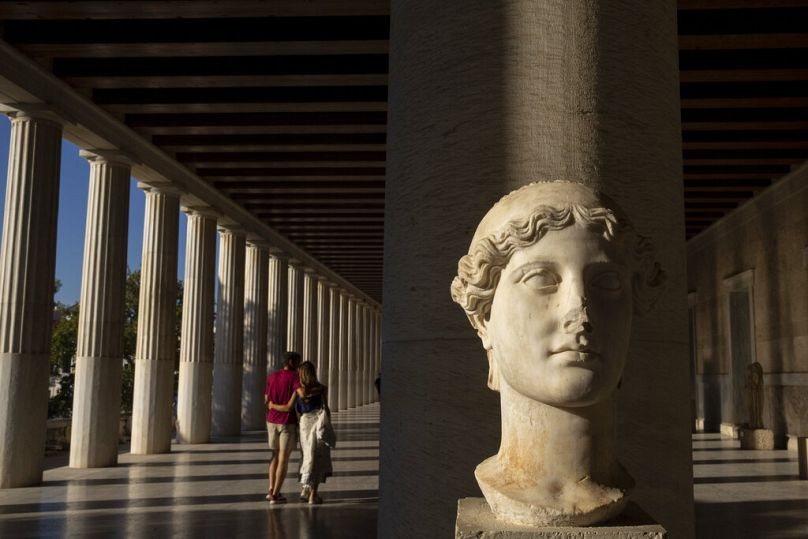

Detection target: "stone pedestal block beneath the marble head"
[455, 498, 668, 539]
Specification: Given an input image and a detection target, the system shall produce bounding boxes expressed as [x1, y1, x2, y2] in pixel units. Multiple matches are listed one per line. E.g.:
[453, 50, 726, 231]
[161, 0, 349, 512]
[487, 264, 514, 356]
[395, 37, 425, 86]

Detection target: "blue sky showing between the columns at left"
[0, 116, 186, 303]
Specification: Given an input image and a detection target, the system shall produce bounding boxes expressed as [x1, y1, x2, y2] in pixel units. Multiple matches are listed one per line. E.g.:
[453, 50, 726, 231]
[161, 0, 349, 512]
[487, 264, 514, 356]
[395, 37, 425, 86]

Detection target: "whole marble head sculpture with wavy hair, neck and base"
[452, 181, 665, 526]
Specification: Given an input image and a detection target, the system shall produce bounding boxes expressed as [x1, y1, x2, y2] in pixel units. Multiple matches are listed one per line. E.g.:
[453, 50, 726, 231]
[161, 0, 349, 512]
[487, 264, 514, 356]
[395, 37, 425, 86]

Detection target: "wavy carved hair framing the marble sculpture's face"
[451, 204, 666, 340]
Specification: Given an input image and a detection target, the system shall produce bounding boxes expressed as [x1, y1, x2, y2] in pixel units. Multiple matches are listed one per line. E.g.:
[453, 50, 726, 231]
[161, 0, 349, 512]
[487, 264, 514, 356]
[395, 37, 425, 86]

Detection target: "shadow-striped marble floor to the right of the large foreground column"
[693, 433, 808, 539]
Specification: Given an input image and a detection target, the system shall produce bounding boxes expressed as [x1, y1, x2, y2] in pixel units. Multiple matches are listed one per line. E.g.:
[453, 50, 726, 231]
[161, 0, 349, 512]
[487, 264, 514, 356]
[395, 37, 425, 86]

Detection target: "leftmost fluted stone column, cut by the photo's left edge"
[0, 113, 62, 488]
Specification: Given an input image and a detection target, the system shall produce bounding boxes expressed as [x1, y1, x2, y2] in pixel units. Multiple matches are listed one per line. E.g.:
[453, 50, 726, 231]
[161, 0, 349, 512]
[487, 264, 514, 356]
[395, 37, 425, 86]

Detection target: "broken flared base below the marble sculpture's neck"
[474, 456, 633, 527]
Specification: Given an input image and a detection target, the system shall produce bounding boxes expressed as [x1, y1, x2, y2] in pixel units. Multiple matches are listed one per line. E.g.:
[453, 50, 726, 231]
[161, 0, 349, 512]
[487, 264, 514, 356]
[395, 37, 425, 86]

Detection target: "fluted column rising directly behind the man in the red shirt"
[267, 250, 289, 371]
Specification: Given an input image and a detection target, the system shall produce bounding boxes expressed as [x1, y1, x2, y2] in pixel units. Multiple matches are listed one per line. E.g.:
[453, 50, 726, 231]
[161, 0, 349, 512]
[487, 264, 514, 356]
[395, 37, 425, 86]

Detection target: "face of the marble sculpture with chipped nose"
[482, 224, 632, 406]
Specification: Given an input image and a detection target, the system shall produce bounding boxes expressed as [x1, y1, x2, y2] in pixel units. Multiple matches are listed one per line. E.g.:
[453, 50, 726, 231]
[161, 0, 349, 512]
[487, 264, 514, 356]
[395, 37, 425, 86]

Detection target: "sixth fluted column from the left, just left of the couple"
[241, 242, 269, 430]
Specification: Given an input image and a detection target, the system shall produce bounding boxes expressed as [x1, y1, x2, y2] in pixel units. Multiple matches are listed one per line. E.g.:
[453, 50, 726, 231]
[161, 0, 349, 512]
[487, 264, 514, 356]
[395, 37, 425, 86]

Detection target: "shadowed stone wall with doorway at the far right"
[687, 164, 808, 447]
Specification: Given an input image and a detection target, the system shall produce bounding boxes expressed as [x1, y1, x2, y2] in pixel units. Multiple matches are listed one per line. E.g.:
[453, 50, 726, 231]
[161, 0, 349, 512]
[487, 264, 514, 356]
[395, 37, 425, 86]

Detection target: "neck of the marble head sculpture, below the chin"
[498, 379, 618, 484]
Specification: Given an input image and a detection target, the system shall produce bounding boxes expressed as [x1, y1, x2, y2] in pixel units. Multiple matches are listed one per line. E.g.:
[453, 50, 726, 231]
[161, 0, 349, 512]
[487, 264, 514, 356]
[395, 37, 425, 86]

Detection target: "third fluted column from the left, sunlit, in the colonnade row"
[131, 184, 180, 455]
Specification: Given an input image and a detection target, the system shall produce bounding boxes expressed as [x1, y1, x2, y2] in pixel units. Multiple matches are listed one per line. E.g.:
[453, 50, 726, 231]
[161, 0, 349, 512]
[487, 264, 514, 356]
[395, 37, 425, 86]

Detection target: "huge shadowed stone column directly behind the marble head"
[378, 0, 693, 538]
